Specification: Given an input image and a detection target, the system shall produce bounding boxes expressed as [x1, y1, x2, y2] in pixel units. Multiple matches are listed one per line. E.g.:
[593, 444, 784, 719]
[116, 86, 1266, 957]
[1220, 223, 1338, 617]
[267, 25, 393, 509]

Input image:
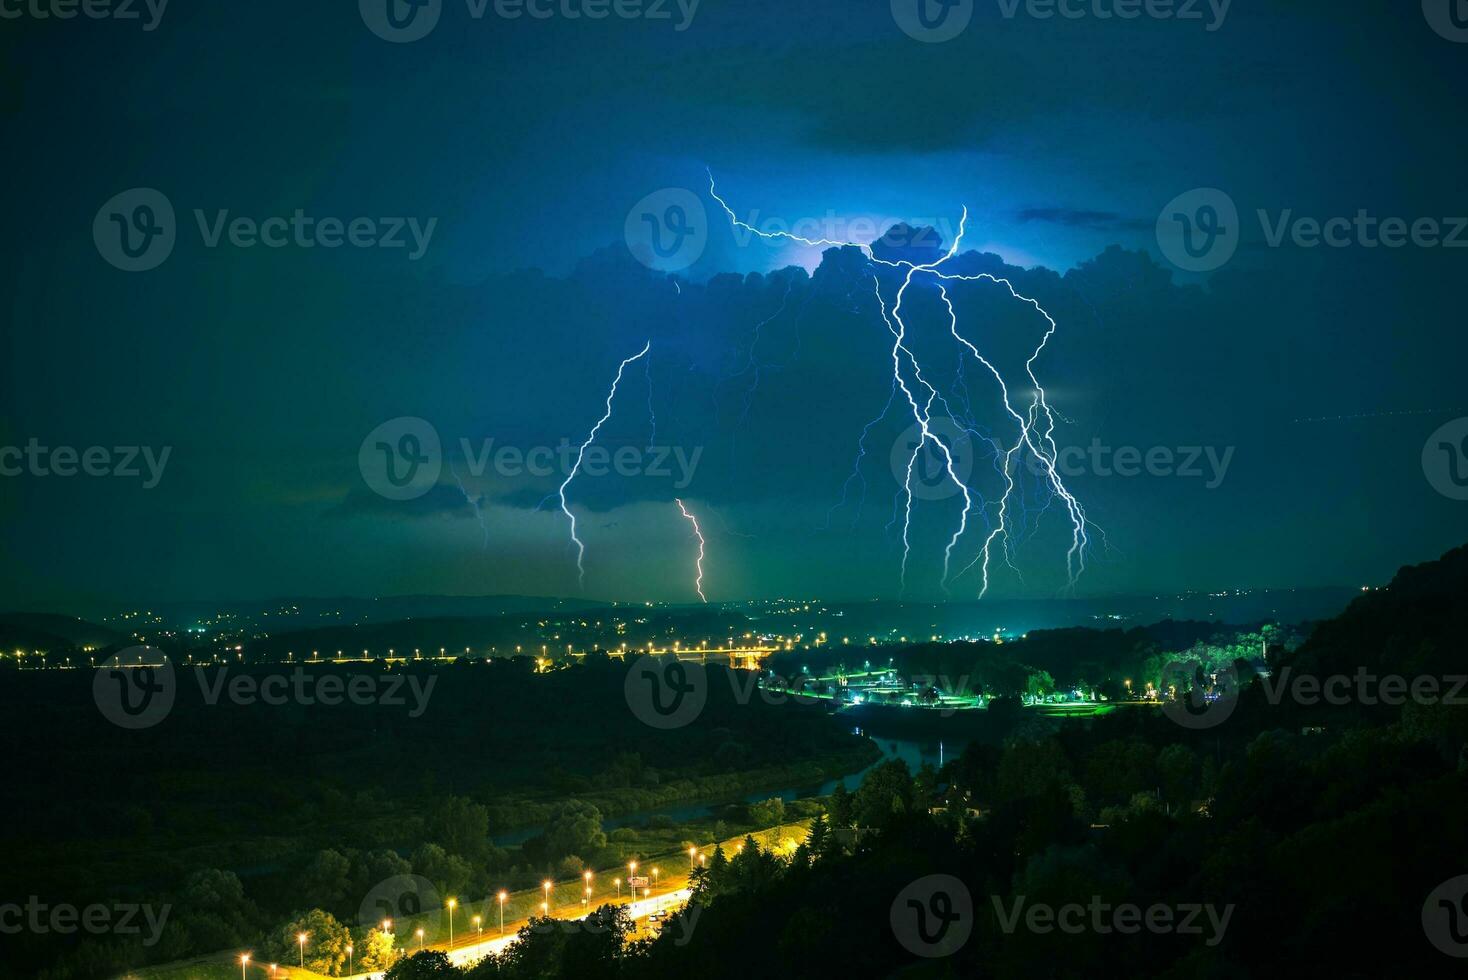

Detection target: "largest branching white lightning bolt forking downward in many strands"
[709, 170, 1089, 599]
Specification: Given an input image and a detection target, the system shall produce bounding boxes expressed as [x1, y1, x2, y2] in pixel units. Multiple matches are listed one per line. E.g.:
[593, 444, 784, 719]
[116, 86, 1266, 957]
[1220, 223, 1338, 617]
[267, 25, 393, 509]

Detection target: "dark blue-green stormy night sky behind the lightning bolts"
[0, 0, 1468, 607]
